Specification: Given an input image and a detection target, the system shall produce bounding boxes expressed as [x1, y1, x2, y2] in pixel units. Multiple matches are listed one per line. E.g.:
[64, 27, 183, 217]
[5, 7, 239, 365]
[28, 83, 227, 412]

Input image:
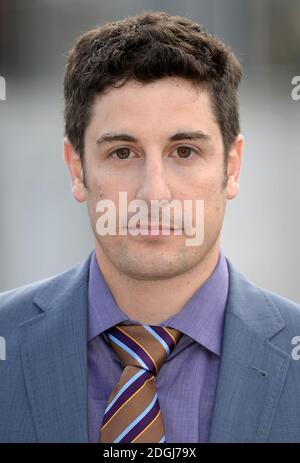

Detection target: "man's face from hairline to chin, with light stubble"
[65, 78, 241, 280]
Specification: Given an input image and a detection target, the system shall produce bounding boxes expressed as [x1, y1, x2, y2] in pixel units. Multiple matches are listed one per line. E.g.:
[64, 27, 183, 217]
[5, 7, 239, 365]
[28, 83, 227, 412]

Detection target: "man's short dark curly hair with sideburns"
[64, 11, 242, 165]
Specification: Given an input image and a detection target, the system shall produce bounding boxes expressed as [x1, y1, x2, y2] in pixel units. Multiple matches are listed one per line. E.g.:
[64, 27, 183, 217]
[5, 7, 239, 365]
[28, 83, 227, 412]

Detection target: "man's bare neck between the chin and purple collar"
[95, 239, 220, 325]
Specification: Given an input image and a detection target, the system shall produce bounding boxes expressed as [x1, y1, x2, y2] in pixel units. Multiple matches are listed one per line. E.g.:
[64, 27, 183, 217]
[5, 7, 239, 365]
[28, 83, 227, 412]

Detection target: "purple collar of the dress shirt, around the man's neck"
[88, 250, 229, 355]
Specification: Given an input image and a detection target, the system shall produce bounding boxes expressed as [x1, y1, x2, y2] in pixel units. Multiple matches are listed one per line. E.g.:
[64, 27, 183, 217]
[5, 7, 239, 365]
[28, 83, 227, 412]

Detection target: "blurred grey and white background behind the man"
[0, 0, 300, 303]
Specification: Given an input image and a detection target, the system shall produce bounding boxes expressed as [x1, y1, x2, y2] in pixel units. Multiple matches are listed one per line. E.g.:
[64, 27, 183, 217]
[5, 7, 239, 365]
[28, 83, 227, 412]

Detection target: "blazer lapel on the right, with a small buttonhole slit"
[209, 261, 290, 442]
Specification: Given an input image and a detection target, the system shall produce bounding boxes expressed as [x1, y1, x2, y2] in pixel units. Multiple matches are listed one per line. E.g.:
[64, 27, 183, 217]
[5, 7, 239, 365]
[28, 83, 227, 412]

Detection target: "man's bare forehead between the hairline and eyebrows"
[88, 77, 218, 139]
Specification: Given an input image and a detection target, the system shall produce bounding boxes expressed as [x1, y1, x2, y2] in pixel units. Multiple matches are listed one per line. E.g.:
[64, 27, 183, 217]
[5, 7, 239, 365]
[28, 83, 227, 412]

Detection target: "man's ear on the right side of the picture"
[226, 134, 244, 199]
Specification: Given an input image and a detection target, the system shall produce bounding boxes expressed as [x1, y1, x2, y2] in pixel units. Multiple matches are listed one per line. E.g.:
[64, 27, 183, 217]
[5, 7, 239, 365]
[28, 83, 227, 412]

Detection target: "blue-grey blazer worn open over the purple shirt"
[0, 255, 300, 442]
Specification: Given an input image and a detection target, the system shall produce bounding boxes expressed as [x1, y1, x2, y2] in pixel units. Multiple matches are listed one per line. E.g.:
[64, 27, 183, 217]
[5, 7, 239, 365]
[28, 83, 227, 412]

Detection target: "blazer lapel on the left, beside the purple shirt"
[19, 256, 90, 442]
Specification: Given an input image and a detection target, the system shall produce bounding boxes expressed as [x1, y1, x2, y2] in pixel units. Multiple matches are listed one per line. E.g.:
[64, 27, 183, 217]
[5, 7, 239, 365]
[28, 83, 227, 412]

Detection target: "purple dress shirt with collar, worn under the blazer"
[88, 250, 228, 443]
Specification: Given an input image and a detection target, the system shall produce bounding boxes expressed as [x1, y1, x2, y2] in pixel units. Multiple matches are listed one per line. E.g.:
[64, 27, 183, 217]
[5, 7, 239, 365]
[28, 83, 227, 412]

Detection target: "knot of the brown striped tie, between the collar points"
[106, 325, 182, 376]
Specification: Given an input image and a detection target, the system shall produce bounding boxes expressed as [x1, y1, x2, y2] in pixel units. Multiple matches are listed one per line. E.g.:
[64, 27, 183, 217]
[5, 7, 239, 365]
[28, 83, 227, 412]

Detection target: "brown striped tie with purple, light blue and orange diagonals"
[99, 325, 182, 443]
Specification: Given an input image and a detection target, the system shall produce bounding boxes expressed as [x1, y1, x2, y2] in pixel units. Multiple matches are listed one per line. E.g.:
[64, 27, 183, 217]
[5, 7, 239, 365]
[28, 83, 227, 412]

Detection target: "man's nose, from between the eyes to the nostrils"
[136, 153, 171, 206]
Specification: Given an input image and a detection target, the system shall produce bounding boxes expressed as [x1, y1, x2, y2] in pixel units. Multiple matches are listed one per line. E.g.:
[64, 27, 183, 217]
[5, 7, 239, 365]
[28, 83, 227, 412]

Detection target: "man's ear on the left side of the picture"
[64, 137, 86, 203]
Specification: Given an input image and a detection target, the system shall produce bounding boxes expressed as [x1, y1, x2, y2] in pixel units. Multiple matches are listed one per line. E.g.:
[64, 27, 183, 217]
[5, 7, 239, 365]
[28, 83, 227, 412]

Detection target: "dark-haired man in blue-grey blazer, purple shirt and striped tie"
[0, 12, 300, 443]
